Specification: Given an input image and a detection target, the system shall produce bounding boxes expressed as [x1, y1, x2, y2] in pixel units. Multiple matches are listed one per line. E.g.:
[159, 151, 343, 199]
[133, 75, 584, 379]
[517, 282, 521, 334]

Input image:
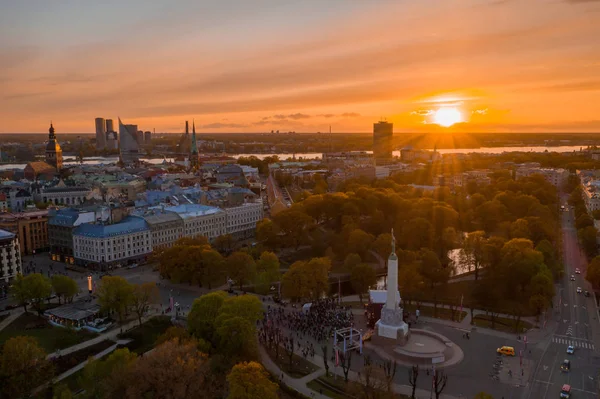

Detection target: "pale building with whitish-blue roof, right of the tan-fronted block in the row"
[164, 204, 227, 240]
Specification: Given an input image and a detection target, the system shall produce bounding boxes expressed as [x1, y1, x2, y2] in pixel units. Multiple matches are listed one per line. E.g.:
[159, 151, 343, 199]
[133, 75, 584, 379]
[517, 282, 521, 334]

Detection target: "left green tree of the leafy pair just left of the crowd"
[188, 291, 227, 344]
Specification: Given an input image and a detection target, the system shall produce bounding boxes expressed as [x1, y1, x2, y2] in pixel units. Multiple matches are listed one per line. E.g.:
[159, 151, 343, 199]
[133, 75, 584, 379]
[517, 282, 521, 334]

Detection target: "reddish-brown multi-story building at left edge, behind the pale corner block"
[0, 210, 49, 255]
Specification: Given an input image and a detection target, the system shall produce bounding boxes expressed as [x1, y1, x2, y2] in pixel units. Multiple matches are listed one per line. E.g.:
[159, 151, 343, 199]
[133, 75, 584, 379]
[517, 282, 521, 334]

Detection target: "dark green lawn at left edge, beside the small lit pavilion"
[0, 313, 97, 353]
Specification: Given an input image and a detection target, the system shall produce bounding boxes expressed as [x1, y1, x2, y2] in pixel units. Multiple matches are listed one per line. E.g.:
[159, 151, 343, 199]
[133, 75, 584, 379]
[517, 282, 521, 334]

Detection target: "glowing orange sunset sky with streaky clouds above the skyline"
[0, 0, 600, 134]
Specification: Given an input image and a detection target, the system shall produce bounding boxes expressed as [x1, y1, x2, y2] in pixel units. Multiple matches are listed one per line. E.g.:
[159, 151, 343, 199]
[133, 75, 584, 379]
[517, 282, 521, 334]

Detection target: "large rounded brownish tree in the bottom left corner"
[0, 336, 52, 398]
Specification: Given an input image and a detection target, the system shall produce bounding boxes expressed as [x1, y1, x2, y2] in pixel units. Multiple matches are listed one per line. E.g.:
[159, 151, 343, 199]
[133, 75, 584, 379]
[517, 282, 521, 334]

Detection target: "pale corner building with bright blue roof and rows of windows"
[73, 216, 152, 268]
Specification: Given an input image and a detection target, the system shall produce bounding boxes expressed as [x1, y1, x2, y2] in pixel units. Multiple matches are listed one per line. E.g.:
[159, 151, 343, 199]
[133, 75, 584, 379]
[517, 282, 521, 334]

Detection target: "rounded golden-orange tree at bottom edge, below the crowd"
[227, 362, 279, 399]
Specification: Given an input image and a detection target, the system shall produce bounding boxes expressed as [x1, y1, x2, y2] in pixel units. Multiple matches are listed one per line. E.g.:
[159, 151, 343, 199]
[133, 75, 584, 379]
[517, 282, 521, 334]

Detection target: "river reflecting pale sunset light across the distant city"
[0, 145, 583, 170]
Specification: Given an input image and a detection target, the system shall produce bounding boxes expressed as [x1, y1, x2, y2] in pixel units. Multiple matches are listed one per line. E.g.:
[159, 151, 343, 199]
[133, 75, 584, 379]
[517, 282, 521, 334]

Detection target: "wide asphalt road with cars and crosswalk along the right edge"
[524, 196, 600, 399]
